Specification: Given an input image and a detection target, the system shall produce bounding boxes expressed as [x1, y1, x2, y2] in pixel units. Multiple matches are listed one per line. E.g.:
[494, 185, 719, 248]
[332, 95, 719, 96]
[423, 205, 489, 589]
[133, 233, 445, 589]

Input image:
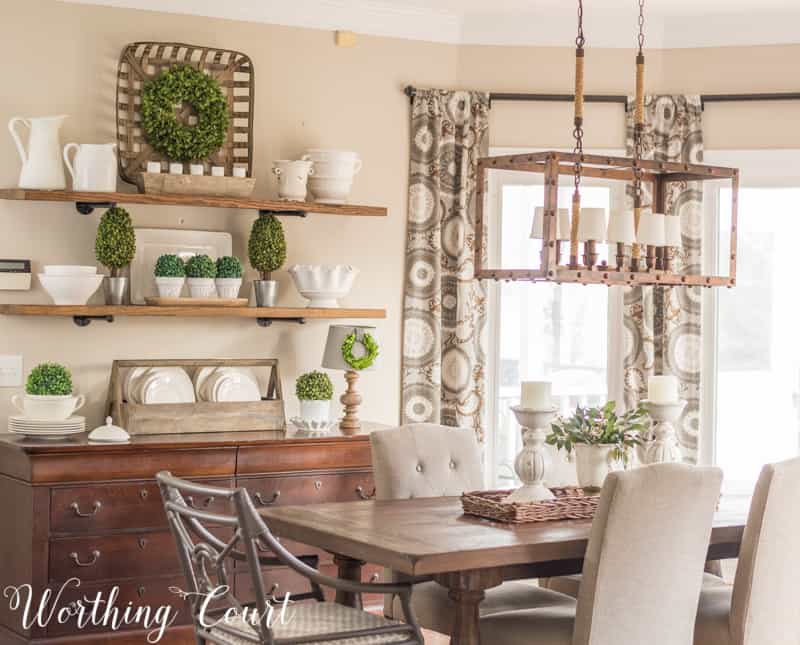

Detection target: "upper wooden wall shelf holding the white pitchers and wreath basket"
[0, 188, 387, 217]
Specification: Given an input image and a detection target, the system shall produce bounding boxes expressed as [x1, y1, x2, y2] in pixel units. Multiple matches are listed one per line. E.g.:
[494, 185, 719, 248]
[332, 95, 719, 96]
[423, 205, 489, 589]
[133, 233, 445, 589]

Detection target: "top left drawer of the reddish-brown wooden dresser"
[50, 479, 233, 535]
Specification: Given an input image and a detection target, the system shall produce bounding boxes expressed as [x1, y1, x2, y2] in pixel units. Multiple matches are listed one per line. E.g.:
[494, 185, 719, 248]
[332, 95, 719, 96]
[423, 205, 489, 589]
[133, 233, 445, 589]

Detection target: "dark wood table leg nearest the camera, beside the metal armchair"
[435, 569, 503, 645]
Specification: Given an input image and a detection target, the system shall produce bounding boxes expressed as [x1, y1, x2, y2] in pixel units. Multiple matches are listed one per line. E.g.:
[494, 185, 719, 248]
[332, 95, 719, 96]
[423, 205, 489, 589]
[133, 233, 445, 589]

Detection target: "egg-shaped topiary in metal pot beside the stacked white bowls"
[94, 206, 136, 305]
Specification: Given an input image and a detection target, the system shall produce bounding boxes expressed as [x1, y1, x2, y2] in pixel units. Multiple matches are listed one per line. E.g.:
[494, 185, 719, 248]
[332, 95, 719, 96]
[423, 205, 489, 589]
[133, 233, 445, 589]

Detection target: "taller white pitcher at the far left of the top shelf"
[8, 114, 67, 190]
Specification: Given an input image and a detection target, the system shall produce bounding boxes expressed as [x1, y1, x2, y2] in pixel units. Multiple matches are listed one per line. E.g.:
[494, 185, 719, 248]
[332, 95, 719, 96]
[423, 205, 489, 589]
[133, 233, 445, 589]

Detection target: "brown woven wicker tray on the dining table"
[461, 486, 599, 524]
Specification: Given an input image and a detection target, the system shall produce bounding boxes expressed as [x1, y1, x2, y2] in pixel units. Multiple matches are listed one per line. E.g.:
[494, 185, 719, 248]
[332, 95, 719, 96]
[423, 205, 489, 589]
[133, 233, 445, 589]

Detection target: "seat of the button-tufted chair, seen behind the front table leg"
[392, 582, 575, 632]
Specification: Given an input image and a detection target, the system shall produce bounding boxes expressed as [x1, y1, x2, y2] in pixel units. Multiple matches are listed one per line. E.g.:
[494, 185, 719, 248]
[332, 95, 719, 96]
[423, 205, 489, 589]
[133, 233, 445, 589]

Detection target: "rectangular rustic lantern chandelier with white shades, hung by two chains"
[475, 0, 739, 287]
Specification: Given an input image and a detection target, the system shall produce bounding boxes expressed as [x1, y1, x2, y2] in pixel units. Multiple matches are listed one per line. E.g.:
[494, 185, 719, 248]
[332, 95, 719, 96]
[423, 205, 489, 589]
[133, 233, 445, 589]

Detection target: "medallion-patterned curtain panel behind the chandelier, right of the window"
[624, 96, 703, 463]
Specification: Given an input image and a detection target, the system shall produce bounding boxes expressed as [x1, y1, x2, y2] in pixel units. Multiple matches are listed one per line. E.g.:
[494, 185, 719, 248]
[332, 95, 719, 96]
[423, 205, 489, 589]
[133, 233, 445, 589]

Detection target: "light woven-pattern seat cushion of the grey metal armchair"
[211, 602, 410, 645]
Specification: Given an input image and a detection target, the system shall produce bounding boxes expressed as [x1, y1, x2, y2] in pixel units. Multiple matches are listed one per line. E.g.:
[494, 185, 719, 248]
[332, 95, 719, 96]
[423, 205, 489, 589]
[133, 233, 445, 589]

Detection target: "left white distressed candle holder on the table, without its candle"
[505, 405, 558, 502]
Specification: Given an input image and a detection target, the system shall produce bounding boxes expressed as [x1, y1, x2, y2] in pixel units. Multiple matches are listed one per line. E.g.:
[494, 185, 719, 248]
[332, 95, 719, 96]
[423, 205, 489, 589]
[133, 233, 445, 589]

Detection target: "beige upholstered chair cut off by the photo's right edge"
[694, 452, 800, 645]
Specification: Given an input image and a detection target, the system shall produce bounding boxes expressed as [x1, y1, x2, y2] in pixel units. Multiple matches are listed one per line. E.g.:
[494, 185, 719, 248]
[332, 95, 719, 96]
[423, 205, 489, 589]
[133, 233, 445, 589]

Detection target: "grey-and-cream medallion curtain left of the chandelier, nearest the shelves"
[402, 90, 489, 439]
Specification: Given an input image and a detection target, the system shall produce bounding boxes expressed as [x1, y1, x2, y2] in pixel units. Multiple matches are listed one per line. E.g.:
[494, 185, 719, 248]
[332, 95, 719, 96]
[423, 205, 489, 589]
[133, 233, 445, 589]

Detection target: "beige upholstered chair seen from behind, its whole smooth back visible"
[480, 464, 722, 645]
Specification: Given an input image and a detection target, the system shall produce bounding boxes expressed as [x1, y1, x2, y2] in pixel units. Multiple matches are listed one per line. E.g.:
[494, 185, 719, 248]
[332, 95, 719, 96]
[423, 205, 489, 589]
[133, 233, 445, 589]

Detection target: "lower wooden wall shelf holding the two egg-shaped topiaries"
[0, 305, 386, 327]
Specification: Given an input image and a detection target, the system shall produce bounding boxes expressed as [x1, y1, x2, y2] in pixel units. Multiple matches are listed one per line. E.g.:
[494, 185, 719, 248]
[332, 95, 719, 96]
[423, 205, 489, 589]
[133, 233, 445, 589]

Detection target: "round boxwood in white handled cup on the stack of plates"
[11, 363, 86, 421]
